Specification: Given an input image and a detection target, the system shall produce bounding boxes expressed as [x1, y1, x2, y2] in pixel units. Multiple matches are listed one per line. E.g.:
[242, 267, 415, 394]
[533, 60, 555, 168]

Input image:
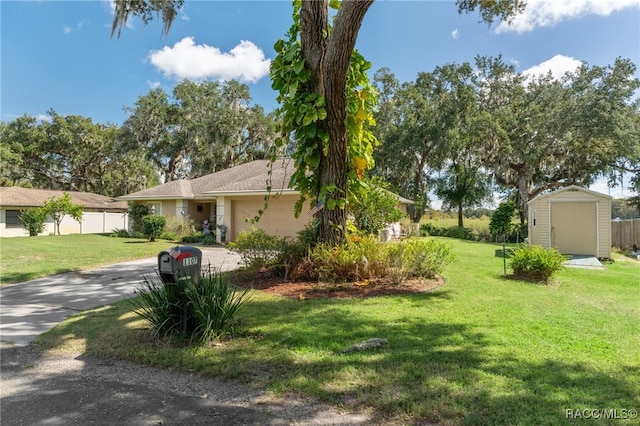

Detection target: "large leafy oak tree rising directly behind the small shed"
[476, 57, 640, 222]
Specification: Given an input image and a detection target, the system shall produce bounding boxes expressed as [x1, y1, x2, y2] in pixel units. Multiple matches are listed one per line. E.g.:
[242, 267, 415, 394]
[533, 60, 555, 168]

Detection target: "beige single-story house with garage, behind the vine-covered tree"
[118, 159, 411, 242]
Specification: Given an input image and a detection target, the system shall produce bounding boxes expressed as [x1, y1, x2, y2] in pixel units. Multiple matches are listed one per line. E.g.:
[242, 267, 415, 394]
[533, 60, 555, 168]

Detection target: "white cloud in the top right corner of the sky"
[496, 0, 640, 33]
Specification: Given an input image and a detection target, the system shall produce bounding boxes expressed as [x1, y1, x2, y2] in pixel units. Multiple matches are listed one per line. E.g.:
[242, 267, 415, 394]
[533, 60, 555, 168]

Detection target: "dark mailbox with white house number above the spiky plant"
[158, 246, 202, 284]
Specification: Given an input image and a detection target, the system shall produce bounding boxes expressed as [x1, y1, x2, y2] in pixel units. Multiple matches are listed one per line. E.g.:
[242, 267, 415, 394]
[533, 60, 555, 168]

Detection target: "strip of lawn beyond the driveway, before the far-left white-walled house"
[0, 234, 172, 285]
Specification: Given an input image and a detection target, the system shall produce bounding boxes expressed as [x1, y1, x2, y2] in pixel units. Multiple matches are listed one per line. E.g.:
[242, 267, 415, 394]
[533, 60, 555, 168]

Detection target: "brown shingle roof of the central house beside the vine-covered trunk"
[118, 159, 295, 200]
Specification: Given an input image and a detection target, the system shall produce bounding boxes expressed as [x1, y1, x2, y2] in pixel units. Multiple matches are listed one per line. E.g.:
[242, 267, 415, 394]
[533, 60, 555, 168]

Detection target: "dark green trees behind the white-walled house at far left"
[0, 110, 158, 197]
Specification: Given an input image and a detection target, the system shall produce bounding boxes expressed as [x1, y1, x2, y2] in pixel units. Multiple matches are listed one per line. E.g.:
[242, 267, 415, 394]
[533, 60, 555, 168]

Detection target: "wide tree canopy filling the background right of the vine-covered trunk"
[374, 56, 640, 221]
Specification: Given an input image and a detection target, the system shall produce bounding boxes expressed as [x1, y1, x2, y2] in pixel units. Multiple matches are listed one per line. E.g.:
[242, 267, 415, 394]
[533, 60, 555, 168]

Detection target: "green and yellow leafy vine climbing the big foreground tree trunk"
[259, 0, 378, 242]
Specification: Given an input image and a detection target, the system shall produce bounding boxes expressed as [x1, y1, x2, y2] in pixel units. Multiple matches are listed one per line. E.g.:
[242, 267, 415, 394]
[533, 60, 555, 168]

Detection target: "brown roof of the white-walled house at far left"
[0, 186, 128, 211]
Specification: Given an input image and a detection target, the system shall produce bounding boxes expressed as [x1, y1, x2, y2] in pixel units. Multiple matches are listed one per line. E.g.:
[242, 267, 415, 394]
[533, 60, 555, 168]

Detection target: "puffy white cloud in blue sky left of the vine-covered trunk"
[149, 37, 271, 83]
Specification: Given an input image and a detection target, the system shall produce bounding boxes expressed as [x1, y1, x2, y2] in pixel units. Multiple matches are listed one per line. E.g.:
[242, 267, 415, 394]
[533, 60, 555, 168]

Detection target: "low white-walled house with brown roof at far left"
[0, 186, 129, 237]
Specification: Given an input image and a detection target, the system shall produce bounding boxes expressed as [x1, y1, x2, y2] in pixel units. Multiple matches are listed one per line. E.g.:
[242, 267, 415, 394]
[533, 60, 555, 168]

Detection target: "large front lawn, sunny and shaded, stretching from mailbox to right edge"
[38, 240, 640, 425]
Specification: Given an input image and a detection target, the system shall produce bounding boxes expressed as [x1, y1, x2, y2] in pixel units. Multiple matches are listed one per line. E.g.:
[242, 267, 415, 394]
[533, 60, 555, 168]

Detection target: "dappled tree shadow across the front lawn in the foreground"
[22, 289, 640, 424]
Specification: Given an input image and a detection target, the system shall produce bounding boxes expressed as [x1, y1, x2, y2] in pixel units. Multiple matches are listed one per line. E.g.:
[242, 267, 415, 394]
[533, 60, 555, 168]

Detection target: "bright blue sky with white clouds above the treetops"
[0, 0, 640, 197]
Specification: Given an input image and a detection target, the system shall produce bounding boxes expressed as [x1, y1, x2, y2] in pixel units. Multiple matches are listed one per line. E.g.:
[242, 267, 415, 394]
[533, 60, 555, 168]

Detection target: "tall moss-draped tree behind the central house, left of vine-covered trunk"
[123, 80, 275, 182]
